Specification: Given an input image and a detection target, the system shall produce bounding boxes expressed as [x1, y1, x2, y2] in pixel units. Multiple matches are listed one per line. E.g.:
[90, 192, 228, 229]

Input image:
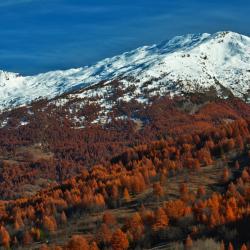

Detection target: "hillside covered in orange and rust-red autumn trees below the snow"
[0, 92, 250, 249]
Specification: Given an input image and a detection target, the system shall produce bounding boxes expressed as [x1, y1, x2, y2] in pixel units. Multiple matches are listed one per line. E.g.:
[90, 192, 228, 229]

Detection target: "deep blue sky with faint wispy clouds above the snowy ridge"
[0, 0, 250, 75]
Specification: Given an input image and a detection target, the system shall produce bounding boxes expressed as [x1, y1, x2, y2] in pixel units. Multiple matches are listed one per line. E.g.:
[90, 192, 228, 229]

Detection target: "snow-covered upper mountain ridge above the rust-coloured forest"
[0, 32, 250, 109]
